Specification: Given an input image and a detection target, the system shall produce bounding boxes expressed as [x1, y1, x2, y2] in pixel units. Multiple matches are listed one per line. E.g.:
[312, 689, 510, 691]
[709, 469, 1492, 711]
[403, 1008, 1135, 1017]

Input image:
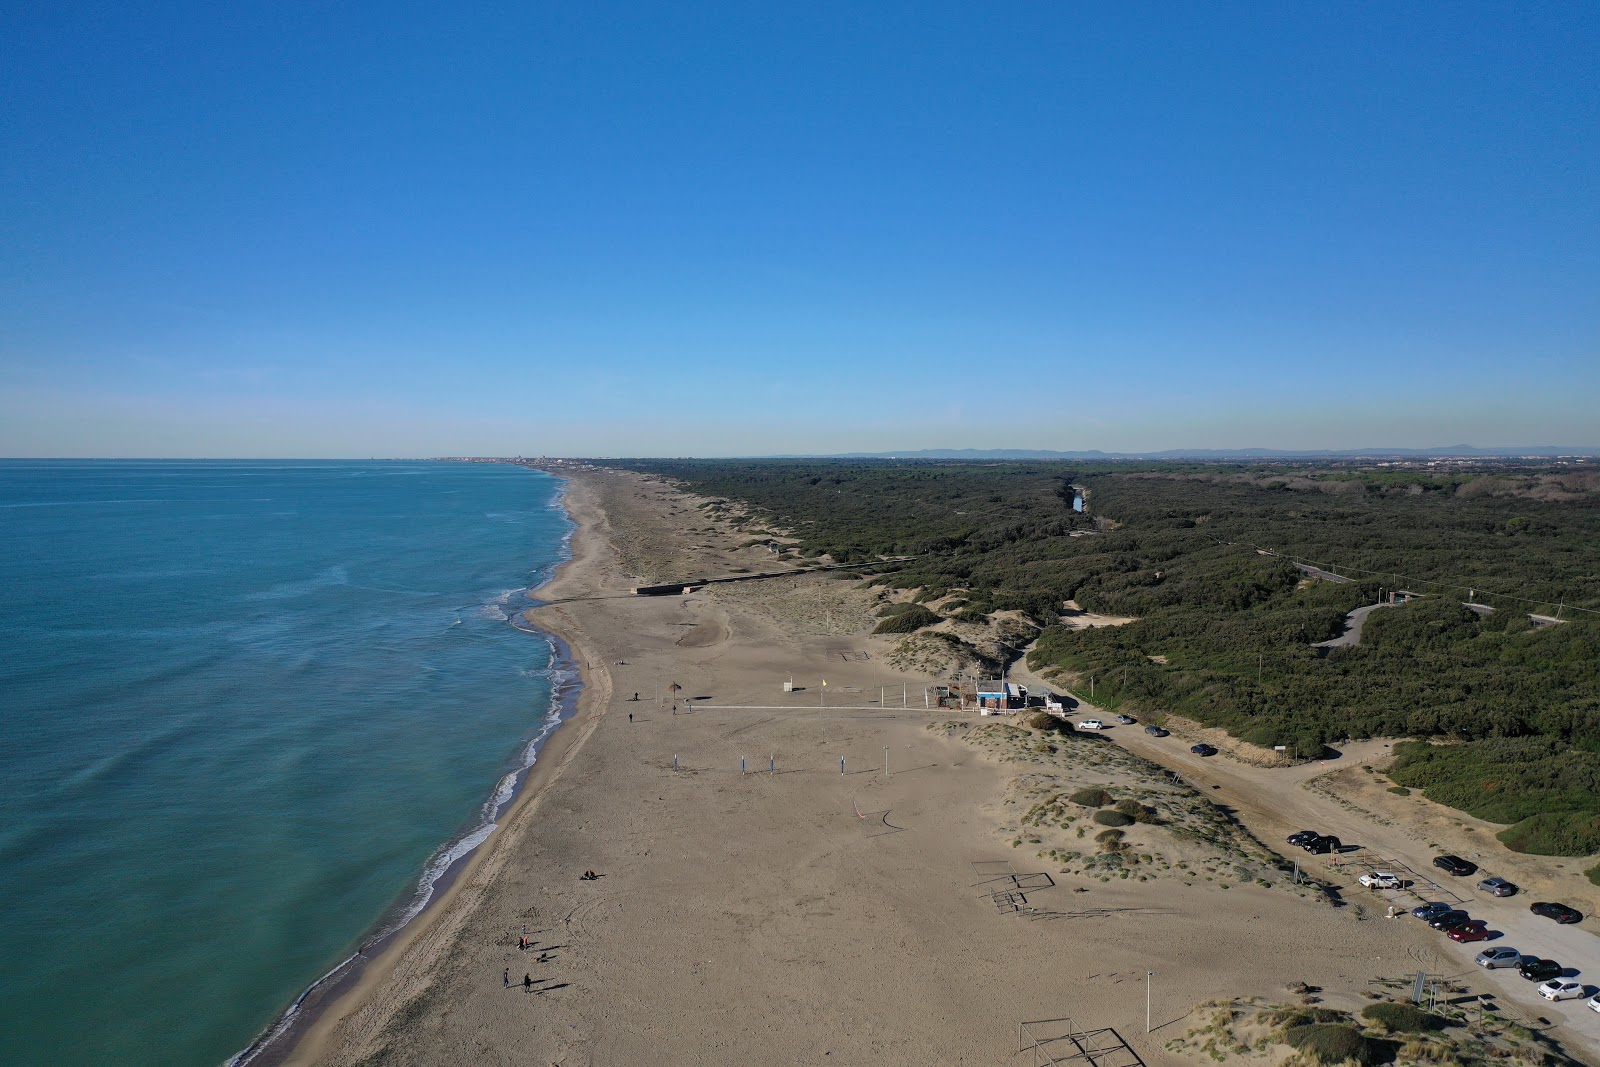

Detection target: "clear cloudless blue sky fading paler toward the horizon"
[0, 0, 1600, 456]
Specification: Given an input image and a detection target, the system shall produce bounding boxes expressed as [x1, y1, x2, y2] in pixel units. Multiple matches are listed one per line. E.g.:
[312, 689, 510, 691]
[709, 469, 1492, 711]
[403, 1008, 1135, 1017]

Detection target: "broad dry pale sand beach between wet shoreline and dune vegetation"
[284, 472, 1452, 1064]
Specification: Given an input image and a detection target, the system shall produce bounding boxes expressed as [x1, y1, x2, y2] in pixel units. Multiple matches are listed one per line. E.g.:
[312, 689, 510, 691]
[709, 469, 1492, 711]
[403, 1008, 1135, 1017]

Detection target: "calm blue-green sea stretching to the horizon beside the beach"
[0, 461, 570, 1065]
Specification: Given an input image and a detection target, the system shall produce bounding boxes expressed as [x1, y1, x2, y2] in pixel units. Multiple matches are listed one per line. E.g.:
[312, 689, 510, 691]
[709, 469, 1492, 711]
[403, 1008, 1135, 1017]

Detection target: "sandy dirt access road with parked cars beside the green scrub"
[1013, 659, 1600, 1064]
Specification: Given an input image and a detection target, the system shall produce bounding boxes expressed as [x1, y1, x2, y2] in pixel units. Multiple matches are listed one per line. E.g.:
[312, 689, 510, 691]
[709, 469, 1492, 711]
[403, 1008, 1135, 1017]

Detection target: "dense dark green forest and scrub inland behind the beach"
[601, 461, 1600, 851]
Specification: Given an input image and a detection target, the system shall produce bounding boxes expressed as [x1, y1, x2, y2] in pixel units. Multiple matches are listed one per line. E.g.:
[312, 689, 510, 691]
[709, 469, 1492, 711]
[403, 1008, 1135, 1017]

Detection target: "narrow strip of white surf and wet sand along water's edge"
[224, 472, 589, 1067]
